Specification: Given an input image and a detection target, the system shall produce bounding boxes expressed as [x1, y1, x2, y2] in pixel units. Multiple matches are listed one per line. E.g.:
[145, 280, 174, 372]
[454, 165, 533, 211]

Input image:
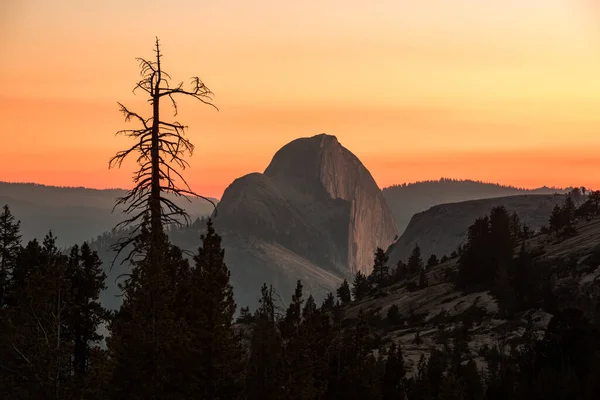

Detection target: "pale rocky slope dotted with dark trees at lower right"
[345, 215, 600, 376]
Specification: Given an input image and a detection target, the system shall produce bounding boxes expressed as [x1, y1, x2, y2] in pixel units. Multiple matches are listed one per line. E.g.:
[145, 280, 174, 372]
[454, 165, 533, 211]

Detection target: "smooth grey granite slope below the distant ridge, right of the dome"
[388, 194, 565, 265]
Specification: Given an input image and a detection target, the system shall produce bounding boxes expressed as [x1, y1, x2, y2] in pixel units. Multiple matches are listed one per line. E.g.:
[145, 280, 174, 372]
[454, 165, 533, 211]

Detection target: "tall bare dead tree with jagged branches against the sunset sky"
[109, 38, 218, 263]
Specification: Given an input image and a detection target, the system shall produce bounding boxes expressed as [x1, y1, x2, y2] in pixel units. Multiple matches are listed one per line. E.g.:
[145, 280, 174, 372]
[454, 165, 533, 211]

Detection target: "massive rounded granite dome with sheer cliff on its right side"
[215, 134, 398, 306]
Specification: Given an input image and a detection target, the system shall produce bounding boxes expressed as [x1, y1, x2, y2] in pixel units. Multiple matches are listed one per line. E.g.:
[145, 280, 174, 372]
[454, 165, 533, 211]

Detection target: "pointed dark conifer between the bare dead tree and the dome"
[184, 219, 243, 400]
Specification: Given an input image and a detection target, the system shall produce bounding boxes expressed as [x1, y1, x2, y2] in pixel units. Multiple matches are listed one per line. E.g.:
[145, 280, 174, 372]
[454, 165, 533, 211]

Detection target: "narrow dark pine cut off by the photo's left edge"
[0, 205, 21, 309]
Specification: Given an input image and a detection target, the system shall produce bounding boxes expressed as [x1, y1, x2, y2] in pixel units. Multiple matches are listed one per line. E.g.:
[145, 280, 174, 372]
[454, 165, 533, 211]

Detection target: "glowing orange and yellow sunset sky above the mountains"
[0, 0, 600, 197]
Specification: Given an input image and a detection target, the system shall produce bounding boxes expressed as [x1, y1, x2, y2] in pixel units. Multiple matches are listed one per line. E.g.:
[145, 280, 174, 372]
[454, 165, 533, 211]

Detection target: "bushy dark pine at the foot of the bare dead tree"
[107, 227, 195, 400]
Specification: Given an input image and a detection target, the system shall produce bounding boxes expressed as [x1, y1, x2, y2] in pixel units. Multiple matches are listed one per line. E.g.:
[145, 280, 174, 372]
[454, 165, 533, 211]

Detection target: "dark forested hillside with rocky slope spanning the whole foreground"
[0, 189, 600, 400]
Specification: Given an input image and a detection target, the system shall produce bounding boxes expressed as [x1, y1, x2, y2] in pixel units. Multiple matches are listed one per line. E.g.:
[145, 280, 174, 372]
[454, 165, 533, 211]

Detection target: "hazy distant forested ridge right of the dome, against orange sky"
[382, 178, 570, 232]
